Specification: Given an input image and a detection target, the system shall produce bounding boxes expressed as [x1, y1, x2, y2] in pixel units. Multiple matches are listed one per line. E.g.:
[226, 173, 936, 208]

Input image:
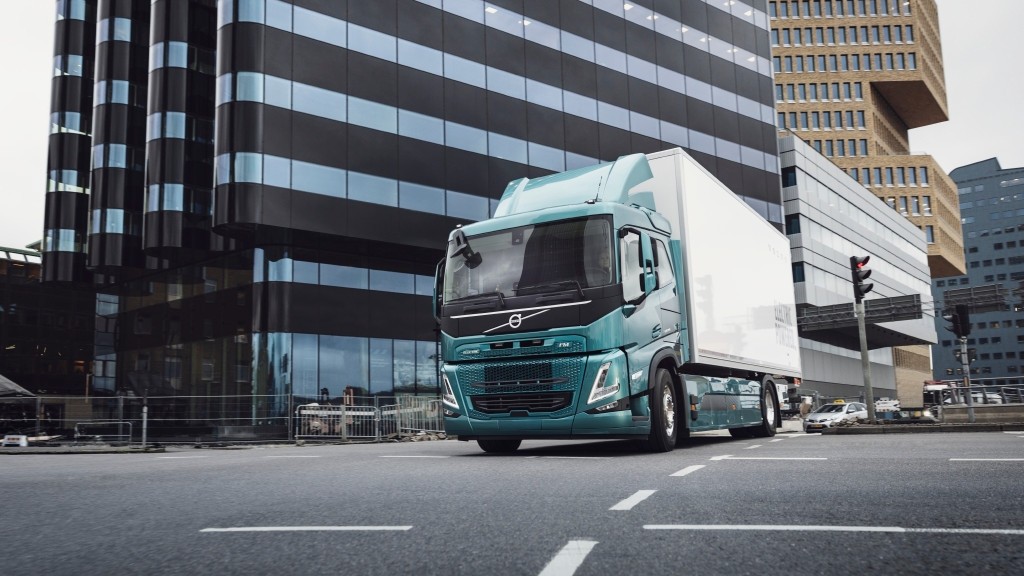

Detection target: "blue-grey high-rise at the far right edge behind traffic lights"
[932, 158, 1024, 385]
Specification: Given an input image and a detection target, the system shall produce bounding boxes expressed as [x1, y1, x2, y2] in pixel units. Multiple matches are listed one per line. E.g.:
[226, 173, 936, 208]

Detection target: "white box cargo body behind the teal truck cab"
[637, 149, 801, 377]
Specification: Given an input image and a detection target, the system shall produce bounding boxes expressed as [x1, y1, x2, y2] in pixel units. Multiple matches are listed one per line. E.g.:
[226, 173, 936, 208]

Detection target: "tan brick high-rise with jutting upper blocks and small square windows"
[768, 0, 965, 404]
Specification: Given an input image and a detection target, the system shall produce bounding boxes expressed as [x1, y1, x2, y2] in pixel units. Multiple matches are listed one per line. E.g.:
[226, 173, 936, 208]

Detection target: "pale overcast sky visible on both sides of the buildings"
[0, 0, 1024, 248]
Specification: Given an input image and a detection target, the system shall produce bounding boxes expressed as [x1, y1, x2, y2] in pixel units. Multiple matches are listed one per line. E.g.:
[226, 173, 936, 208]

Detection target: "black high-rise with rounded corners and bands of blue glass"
[37, 0, 782, 434]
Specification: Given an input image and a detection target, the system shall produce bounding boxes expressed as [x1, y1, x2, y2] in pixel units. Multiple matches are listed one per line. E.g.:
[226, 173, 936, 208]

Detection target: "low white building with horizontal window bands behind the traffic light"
[779, 136, 936, 406]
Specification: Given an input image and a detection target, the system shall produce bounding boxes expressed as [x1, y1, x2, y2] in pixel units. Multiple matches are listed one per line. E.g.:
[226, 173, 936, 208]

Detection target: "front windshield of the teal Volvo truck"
[444, 216, 616, 303]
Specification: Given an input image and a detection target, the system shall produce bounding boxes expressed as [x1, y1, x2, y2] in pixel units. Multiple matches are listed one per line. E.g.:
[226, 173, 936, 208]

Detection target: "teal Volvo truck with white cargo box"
[434, 149, 800, 452]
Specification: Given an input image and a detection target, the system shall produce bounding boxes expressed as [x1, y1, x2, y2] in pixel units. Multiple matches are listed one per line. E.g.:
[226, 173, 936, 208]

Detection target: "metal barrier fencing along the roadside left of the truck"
[0, 395, 443, 444]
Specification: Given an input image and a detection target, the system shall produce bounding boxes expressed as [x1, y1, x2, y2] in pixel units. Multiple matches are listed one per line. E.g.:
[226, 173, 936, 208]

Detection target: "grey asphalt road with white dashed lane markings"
[0, 433, 1024, 576]
